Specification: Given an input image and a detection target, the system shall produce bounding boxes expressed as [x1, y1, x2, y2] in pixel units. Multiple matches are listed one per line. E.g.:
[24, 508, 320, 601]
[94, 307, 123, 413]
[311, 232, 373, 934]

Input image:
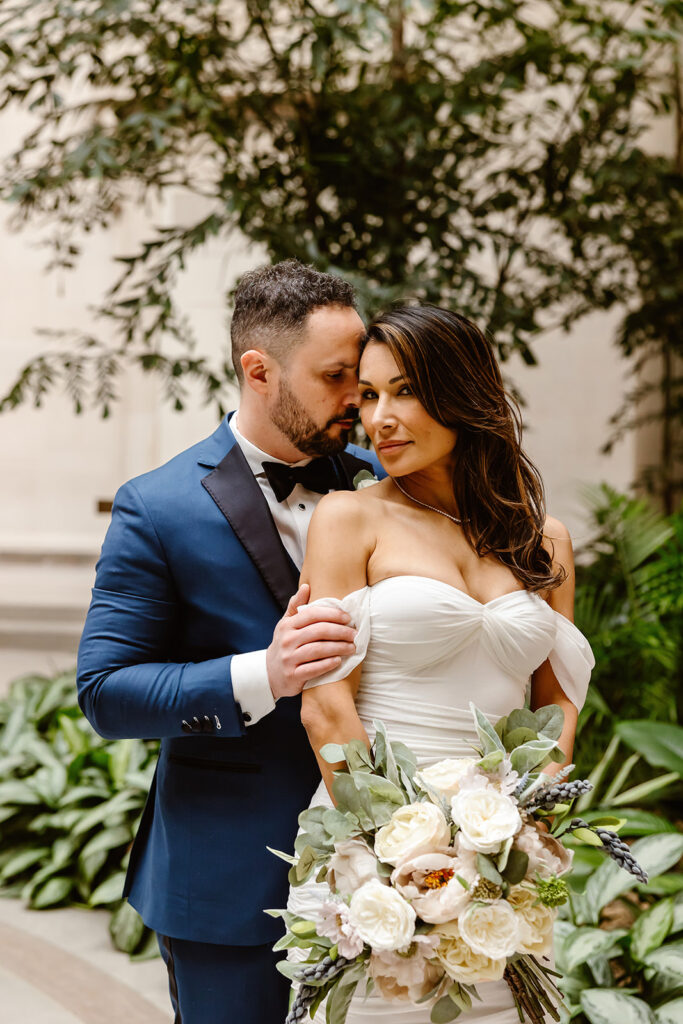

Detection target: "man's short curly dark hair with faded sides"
[230, 259, 355, 383]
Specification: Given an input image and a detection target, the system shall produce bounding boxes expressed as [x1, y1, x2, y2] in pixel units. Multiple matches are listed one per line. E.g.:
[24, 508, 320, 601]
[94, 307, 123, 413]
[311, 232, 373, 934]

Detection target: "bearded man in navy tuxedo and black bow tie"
[78, 260, 385, 1024]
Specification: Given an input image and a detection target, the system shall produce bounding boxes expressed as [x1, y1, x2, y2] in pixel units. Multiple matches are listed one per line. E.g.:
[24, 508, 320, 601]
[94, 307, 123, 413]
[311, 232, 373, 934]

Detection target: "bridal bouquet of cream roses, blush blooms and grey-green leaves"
[267, 705, 646, 1024]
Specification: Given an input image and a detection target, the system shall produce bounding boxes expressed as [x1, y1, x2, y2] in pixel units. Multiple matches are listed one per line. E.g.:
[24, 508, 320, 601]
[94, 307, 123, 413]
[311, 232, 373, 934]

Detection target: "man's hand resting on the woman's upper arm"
[265, 583, 355, 700]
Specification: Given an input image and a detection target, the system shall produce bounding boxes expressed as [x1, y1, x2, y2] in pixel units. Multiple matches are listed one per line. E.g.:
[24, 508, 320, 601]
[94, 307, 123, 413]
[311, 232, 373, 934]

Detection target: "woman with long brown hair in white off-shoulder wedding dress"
[289, 306, 594, 1024]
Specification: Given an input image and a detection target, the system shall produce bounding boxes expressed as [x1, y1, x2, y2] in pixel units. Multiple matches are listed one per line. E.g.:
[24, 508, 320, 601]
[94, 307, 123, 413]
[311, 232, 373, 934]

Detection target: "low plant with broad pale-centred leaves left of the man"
[0, 673, 158, 956]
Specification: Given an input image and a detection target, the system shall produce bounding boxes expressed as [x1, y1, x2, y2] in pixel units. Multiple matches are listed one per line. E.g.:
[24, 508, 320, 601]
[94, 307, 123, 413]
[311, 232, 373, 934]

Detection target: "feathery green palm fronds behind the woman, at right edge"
[574, 484, 683, 775]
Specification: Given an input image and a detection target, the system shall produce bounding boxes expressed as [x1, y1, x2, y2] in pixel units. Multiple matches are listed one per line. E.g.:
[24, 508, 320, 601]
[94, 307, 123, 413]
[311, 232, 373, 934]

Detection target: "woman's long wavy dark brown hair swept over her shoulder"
[365, 305, 566, 591]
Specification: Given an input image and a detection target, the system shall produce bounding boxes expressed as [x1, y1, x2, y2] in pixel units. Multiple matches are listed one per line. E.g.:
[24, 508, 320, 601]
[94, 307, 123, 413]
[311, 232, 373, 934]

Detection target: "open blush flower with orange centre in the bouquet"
[391, 849, 477, 925]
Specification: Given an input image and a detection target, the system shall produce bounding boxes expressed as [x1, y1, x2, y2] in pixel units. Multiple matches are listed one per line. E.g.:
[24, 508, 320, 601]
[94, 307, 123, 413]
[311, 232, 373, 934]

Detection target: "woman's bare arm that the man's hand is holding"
[301, 492, 374, 796]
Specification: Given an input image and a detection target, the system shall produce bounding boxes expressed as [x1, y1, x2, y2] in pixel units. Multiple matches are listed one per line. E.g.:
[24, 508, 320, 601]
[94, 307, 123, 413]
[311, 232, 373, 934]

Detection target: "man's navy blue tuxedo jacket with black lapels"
[78, 419, 384, 945]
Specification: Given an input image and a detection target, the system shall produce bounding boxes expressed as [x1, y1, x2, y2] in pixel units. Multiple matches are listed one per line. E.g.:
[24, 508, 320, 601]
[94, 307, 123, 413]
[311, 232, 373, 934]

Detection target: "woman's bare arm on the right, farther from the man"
[530, 517, 579, 775]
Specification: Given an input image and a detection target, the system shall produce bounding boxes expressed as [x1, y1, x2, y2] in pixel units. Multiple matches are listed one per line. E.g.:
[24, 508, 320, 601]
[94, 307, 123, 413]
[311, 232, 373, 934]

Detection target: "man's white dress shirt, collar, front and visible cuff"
[230, 413, 331, 725]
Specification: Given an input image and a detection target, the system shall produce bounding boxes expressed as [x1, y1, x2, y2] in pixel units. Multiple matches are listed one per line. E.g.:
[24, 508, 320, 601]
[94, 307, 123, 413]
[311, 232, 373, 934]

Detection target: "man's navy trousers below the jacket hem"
[158, 935, 290, 1024]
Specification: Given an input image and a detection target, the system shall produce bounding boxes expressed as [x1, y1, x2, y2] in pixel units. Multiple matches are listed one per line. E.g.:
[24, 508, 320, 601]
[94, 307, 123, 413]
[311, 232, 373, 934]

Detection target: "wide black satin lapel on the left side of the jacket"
[202, 444, 299, 610]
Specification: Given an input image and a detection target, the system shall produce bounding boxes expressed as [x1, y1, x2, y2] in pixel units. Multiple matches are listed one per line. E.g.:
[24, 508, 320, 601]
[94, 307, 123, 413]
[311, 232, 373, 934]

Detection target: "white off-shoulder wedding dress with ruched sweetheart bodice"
[288, 575, 595, 1024]
